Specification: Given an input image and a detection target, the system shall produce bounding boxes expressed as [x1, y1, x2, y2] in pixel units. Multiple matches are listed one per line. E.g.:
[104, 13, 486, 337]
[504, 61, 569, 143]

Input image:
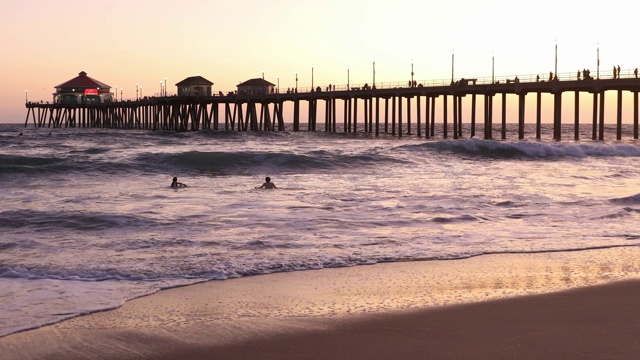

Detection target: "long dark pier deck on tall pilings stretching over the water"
[25, 76, 640, 140]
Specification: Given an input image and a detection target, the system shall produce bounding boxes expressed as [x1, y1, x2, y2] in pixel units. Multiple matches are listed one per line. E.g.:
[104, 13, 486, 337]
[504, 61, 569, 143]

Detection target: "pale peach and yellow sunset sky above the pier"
[0, 0, 640, 123]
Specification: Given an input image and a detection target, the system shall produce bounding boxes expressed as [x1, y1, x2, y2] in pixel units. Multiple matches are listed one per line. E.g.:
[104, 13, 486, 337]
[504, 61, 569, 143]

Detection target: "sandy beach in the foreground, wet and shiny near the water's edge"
[0, 247, 640, 359]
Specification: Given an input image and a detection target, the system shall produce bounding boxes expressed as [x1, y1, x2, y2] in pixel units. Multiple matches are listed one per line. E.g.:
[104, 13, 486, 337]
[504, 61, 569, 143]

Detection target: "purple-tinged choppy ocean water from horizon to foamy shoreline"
[0, 124, 640, 336]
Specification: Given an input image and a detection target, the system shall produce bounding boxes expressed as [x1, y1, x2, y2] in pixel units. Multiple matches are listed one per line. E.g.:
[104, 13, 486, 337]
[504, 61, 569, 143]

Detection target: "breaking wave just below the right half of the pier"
[400, 138, 640, 158]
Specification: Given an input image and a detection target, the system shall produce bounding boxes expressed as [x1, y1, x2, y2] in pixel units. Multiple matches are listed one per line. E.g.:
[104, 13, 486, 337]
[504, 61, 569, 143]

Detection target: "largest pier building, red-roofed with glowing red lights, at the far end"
[53, 71, 113, 104]
